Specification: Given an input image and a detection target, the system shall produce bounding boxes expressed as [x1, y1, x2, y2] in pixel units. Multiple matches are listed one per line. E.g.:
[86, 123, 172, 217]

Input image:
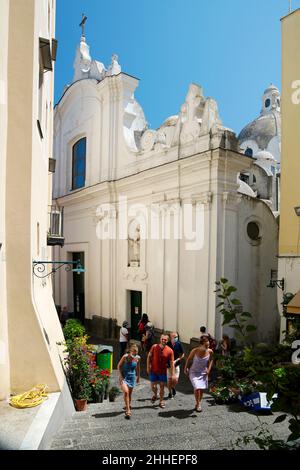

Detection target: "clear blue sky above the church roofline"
[55, 0, 300, 133]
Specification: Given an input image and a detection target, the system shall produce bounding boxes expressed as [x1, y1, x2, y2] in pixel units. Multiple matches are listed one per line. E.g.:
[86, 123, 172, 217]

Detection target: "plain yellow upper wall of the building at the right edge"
[279, 9, 300, 256]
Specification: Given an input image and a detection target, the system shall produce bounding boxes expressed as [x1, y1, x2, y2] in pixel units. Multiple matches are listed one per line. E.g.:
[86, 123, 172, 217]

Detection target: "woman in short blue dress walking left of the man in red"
[117, 344, 141, 419]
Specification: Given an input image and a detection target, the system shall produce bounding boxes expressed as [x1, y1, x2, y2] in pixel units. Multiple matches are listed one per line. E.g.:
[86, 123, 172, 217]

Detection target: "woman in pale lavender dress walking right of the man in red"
[184, 336, 213, 412]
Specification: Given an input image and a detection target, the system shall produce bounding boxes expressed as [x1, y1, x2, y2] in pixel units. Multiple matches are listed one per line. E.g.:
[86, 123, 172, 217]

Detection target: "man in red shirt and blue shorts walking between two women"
[147, 334, 175, 408]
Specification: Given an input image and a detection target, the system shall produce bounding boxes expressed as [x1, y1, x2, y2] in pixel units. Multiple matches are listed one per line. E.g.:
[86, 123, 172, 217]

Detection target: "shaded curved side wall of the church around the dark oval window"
[237, 196, 279, 341]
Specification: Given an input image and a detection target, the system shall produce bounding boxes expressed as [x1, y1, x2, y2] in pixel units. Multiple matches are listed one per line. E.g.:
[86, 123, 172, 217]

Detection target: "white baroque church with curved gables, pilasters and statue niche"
[53, 30, 280, 344]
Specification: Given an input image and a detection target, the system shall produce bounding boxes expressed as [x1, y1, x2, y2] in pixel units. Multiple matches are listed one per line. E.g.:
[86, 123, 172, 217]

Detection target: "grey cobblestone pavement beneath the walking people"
[51, 360, 289, 452]
